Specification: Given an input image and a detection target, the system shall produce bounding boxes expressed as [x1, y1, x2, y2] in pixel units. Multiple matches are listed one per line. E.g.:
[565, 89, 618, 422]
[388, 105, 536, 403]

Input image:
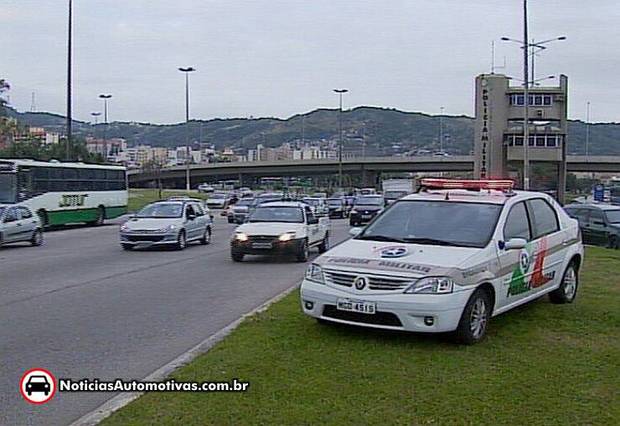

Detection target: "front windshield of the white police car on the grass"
[357, 200, 502, 248]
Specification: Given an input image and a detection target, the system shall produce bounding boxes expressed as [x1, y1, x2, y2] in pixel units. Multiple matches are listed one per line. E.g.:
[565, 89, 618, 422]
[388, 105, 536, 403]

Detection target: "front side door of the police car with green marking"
[497, 201, 532, 308]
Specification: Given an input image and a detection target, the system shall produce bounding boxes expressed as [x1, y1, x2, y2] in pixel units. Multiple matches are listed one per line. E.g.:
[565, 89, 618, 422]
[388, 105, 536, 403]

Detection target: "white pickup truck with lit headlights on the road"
[230, 201, 331, 262]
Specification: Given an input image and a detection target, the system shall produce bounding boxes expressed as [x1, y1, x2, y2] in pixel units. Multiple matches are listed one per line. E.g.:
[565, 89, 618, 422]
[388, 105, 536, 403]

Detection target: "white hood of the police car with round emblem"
[315, 239, 487, 277]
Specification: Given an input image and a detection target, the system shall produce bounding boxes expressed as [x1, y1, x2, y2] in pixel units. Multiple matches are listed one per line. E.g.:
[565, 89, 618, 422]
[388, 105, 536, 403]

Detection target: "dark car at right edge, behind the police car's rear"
[564, 203, 620, 249]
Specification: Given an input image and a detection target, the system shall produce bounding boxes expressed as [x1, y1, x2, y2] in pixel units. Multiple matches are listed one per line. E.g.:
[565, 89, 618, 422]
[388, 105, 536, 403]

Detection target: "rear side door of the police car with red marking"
[525, 198, 567, 292]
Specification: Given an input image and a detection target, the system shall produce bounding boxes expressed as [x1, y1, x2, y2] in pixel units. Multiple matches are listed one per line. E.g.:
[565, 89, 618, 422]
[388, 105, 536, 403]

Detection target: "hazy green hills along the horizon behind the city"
[9, 107, 620, 155]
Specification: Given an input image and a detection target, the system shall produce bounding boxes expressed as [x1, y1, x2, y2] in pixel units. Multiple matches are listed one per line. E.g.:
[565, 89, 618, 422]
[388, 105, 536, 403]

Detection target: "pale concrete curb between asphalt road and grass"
[71, 284, 299, 426]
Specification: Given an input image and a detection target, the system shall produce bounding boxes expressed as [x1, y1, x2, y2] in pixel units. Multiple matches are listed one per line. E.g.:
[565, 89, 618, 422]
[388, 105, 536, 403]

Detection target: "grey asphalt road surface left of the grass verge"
[0, 217, 348, 425]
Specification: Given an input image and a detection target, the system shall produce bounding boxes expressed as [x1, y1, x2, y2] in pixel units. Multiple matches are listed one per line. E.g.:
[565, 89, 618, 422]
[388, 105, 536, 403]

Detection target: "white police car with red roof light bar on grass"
[301, 179, 583, 344]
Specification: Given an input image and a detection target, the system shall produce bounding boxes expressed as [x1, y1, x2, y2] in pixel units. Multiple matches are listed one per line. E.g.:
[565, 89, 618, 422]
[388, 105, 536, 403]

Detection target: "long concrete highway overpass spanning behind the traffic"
[129, 156, 620, 188]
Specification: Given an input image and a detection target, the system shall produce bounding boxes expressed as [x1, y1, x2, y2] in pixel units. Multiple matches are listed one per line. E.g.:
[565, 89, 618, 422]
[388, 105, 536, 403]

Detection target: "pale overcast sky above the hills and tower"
[0, 0, 620, 123]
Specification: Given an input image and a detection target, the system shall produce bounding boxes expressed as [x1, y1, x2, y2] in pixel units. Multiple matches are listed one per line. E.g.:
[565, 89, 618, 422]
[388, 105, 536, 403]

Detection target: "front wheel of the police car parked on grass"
[456, 289, 491, 345]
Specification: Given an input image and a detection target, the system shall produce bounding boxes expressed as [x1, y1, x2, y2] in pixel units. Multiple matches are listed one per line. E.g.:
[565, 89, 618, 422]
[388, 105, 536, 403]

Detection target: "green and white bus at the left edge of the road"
[0, 159, 128, 226]
